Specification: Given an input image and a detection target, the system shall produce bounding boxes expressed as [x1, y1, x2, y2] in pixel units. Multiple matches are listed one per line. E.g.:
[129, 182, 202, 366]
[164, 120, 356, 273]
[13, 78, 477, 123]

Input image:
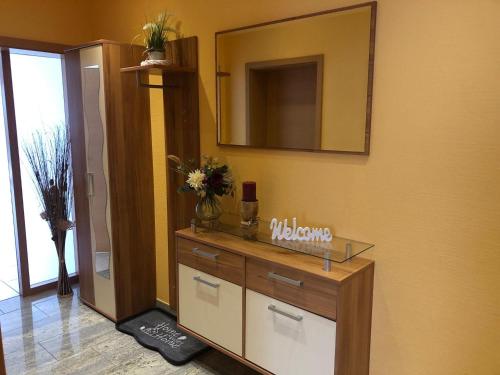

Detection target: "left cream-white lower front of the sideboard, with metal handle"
[179, 264, 243, 356]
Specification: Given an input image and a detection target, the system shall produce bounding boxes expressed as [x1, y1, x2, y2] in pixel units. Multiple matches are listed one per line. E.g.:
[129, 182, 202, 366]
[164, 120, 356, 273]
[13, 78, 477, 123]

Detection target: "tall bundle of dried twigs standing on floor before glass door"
[23, 124, 74, 297]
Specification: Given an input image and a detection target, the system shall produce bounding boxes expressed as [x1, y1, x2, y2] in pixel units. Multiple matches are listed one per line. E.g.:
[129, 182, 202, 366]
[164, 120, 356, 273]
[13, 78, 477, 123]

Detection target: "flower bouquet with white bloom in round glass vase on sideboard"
[168, 155, 234, 226]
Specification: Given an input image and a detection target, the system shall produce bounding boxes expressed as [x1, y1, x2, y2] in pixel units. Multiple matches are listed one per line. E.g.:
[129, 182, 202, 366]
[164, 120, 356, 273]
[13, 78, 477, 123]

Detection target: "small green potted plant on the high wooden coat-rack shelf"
[142, 12, 180, 64]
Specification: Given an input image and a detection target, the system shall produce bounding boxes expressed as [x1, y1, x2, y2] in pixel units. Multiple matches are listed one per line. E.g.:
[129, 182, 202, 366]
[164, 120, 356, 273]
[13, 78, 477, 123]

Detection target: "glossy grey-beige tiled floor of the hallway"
[0, 291, 256, 375]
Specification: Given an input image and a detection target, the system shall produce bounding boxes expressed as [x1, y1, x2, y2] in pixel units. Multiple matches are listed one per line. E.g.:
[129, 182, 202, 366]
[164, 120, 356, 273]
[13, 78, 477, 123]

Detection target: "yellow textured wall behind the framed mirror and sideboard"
[0, 0, 500, 375]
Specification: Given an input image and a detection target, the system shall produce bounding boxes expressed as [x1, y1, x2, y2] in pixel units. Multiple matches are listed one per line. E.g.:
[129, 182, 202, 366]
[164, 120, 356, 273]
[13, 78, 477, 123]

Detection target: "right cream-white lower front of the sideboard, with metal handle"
[245, 289, 335, 375]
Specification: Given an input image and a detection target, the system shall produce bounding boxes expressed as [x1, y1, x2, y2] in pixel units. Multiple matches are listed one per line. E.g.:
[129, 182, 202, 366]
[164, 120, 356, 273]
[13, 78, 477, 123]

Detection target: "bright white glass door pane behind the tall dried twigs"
[10, 50, 76, 286]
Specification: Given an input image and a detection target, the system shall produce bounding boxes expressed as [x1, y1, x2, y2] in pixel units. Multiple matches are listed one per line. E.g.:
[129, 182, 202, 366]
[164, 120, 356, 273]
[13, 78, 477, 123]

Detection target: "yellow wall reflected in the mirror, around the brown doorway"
[217, 7, 371, 151]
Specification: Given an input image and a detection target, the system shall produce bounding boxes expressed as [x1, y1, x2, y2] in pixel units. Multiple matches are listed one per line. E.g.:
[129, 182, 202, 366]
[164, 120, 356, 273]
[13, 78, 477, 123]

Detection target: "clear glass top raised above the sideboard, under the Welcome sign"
[193, 213, 375, 263]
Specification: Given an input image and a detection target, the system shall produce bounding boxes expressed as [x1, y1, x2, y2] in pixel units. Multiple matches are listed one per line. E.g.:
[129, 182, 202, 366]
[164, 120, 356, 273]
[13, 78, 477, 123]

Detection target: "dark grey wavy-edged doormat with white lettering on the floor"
[116, 309, 208, 366]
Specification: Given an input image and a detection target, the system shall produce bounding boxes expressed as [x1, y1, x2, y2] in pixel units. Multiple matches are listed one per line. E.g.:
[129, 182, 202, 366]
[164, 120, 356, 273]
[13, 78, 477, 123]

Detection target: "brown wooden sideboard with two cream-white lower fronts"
[176, 229, 374, 375]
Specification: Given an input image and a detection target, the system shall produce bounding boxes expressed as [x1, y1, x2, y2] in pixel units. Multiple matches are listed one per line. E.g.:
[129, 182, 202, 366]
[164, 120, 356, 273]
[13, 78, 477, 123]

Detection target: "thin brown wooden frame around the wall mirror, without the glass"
[215, 1, 377, 155]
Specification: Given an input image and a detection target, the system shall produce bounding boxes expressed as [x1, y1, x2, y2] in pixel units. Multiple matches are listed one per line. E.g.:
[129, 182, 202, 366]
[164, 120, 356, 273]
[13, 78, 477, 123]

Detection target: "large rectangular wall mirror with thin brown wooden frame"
[215, 2, 376, 154]
